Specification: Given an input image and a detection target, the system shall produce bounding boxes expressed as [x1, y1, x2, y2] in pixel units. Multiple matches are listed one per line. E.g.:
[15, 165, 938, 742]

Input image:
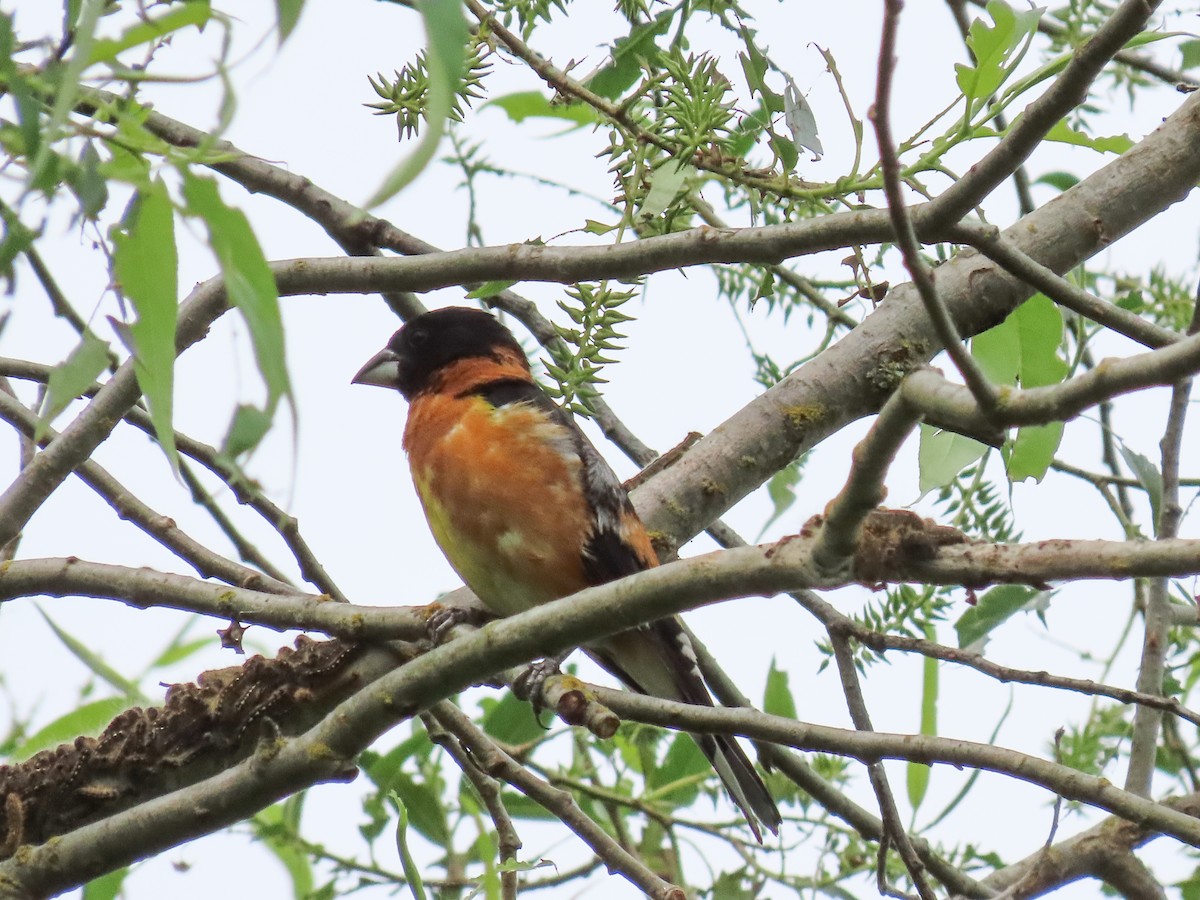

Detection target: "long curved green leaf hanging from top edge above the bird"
[364, 0, 468, 209]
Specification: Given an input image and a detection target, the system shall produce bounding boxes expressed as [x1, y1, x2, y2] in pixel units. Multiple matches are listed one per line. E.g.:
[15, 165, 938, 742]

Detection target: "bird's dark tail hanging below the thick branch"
[586, 617, 781, 844]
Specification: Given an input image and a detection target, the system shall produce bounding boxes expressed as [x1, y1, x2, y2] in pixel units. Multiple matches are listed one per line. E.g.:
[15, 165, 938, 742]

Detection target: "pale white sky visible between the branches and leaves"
[0, 0, 1196, 898]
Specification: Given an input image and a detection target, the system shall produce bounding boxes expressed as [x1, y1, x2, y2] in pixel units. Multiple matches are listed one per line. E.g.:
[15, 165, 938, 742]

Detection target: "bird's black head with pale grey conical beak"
[353, 306, 528, 398]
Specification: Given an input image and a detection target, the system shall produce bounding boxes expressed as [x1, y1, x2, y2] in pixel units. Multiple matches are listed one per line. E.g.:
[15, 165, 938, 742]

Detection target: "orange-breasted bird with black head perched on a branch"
[353, 306, 781, 844]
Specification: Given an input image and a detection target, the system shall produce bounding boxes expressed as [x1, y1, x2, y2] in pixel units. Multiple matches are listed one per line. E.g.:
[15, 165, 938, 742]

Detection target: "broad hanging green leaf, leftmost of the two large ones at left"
[113, 179, 179, 472]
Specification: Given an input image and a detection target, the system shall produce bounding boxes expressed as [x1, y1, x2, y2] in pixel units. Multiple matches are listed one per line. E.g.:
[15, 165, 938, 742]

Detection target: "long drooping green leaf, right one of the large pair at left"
[184, 172, 295, 436]
